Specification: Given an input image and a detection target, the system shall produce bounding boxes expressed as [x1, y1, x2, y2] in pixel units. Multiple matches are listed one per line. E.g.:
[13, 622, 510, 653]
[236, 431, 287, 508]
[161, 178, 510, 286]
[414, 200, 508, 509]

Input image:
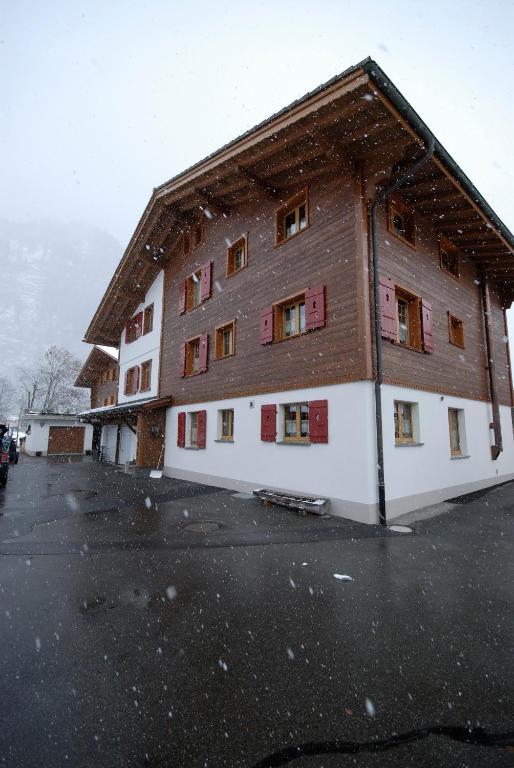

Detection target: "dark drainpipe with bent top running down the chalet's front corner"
[370, 136, 434, 525]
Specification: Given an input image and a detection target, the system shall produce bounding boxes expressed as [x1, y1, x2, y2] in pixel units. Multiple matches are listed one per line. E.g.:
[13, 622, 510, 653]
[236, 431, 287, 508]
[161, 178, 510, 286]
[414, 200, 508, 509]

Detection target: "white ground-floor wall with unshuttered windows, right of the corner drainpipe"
[382, 385, 514, 518]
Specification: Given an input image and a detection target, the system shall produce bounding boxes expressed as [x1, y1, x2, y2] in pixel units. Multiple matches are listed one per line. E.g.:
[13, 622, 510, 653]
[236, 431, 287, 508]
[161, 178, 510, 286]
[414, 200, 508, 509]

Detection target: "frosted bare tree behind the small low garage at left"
[20, 346, 87, 413]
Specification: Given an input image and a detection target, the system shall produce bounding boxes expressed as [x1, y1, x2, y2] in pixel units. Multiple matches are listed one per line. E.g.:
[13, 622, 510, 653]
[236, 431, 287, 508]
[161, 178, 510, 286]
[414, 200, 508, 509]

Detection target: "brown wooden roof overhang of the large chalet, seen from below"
[85, 59, 514, 344]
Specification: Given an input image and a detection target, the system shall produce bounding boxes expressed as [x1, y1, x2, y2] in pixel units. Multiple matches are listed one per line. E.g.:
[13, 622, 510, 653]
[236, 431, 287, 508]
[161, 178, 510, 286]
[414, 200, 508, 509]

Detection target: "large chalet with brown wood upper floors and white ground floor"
[80, 59, 514, 523]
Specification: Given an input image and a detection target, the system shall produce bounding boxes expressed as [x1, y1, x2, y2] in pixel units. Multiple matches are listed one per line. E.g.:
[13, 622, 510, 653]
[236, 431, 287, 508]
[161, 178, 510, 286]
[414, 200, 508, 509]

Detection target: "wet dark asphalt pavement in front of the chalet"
[0, 457, 514, 768]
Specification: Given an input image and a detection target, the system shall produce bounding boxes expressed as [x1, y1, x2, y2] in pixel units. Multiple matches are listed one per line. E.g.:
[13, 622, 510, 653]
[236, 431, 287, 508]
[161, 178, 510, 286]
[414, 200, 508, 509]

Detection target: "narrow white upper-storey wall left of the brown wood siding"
[118, 271, 164, 403]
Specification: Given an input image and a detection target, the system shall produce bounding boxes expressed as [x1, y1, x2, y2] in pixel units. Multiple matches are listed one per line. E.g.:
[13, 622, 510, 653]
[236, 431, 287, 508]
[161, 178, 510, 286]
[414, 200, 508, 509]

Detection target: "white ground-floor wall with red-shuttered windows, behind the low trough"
[164, 382, 376, 522]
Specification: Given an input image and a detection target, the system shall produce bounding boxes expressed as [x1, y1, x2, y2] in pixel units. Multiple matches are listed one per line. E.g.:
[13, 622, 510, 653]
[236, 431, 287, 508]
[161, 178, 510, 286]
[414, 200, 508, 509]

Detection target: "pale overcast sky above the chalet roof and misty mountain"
[0, 0, 514, 330]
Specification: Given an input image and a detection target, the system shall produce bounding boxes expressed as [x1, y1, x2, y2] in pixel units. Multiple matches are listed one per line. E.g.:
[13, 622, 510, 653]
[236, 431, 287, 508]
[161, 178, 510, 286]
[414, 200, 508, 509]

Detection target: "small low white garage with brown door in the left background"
[25, 412, 93, 456]
